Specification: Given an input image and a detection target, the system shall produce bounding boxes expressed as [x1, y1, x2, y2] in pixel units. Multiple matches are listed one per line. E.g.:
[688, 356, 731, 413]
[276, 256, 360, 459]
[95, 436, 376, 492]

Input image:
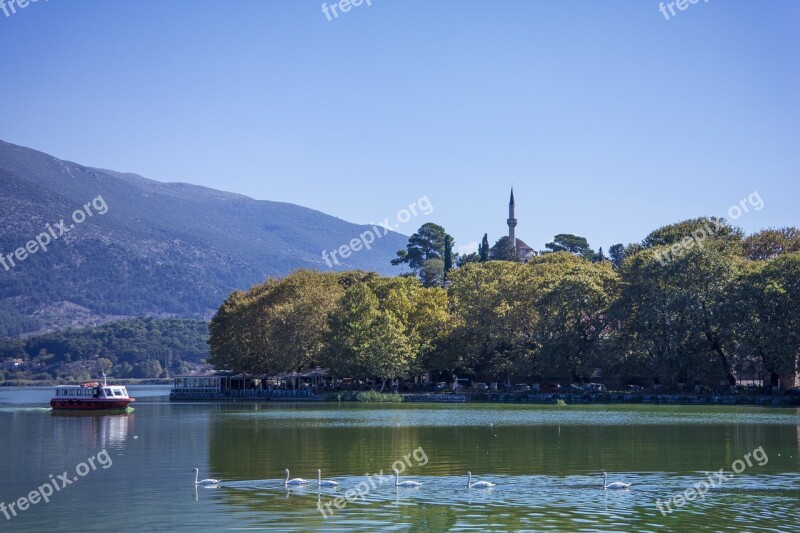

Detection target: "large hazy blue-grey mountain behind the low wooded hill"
[0, 141, 407, 336]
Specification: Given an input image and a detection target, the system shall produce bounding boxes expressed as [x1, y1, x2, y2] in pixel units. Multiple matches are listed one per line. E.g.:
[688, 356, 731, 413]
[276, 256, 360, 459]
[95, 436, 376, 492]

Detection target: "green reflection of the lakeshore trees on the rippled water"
[195, 405, 800, 531]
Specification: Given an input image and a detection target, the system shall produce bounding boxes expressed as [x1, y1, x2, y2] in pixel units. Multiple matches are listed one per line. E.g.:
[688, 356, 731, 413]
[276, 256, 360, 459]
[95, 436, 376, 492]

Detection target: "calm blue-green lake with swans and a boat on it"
[0, 387, 800, 532]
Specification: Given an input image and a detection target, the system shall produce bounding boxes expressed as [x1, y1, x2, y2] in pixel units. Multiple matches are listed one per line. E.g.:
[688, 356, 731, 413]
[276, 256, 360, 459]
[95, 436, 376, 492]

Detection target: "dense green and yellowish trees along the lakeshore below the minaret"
[209, 218, 800, 384]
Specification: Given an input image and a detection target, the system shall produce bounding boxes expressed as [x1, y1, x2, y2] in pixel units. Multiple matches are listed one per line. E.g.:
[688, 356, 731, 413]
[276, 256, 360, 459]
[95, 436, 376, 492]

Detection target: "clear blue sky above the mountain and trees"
[0, 0, 800, 254]
